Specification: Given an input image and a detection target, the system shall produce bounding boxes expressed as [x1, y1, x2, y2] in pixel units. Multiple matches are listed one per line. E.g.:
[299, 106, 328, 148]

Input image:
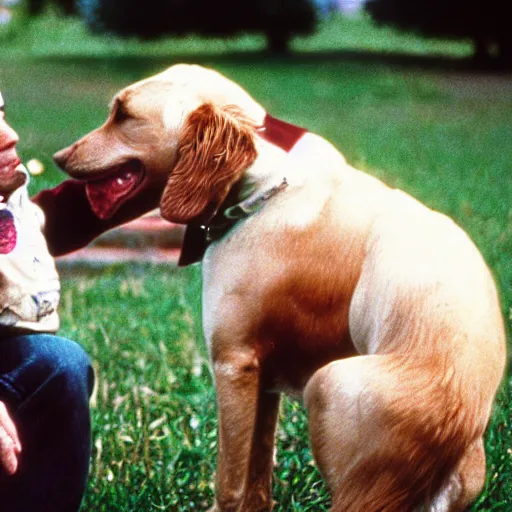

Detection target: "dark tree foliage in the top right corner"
[366, 0, 512, 64]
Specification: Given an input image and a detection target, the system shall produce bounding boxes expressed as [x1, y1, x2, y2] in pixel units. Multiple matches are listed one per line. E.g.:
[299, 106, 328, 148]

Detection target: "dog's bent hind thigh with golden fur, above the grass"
[305, 355, 492, 512]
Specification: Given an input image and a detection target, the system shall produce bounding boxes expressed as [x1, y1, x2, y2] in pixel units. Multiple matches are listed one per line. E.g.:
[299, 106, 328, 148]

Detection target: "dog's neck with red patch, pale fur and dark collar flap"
[179, 114, 307, 266]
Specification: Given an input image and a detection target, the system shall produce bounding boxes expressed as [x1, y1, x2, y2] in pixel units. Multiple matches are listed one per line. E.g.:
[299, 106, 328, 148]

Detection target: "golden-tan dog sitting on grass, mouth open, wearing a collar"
[55, 64, 506, 512]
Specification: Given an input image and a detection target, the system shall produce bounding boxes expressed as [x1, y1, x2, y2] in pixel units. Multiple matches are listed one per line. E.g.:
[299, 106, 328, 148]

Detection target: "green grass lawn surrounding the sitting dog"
[0, 9, 512, 512]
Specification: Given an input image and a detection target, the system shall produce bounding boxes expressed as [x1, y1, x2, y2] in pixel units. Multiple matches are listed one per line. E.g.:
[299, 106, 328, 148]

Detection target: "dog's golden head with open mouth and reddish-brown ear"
[54, 64, 265, 223]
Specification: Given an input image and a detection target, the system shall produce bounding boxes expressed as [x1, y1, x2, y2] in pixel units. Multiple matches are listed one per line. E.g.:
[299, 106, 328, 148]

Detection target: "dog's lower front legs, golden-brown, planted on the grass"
[210, 353, 279, 512]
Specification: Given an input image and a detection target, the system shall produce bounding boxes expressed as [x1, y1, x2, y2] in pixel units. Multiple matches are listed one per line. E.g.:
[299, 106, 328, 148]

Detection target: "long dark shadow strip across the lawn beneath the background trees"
[37, 50, 512, 75]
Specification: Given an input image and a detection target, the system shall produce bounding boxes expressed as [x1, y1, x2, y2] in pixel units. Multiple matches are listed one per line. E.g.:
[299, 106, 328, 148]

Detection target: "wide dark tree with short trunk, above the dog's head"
[79, 0, 316, 52]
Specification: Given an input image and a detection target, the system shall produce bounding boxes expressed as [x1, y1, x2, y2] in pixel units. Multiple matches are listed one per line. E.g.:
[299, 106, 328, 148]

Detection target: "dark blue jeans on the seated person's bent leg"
[0, 334, 94, 512]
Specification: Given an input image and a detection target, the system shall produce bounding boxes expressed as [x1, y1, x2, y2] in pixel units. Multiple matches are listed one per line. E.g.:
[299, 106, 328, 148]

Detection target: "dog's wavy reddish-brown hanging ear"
[160, 103, 257, 224]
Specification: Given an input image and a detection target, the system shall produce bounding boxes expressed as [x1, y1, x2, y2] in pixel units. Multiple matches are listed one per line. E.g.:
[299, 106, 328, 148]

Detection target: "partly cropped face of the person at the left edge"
[0, 93, 26, 200]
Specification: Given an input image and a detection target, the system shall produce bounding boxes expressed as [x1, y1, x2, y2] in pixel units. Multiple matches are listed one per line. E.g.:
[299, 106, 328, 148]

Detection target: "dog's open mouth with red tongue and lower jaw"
[85, 160, 145, 220]
